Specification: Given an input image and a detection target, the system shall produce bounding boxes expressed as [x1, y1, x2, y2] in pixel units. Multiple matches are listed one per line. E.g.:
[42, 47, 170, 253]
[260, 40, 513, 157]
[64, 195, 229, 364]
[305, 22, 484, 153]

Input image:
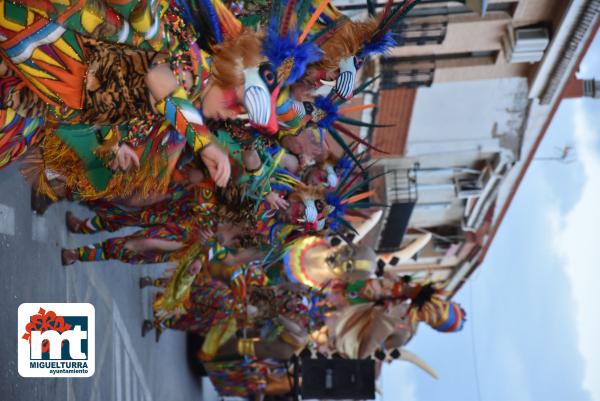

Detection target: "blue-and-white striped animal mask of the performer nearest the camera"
[244, 63, 280, 134]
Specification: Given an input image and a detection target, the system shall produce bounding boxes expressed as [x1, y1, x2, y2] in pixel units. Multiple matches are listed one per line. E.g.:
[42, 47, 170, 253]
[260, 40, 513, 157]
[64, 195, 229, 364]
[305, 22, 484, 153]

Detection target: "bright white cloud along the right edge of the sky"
[549, 97, 600, 401]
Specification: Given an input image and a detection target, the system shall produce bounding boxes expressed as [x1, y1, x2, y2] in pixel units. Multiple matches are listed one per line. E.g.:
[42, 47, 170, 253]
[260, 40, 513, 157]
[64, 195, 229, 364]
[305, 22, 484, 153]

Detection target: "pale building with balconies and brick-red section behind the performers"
[336, 0, 600, 294]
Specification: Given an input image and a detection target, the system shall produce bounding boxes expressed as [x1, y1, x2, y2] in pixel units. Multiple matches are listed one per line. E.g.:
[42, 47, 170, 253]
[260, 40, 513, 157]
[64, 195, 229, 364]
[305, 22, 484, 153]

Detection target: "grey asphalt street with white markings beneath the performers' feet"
[0, 162, 218, 401]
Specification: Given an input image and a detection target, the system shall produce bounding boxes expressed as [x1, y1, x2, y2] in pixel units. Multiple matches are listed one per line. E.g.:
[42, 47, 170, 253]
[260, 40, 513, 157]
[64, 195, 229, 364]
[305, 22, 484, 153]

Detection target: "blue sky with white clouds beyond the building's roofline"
[379, 28, 600, 401]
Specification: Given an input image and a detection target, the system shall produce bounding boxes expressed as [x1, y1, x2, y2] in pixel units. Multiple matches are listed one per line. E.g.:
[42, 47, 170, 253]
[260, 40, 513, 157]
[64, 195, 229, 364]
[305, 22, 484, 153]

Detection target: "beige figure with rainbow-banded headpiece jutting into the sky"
[328, 275, 466, 358]
